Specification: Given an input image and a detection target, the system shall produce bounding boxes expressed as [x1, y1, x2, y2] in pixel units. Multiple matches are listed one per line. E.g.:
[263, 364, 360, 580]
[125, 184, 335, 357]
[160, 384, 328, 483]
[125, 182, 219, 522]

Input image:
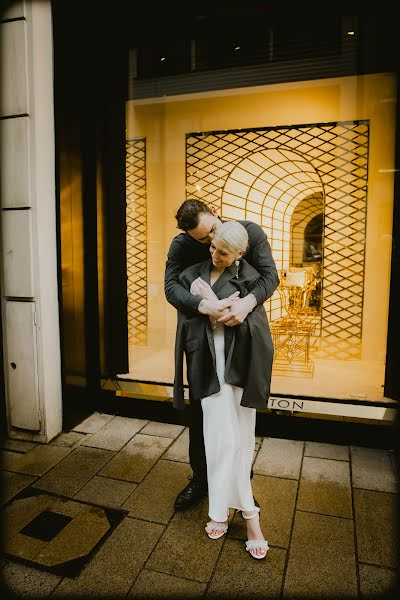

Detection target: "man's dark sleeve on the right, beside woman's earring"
[245, 222, 279, 304]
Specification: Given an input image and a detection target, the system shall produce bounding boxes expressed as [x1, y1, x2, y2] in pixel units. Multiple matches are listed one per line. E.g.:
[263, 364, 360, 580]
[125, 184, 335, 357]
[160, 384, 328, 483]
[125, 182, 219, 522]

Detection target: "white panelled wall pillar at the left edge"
[0, 0, 62, 442]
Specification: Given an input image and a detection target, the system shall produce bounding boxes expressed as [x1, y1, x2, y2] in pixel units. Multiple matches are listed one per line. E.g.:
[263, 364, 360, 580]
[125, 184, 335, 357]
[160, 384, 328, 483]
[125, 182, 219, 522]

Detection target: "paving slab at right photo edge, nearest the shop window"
[350, 446, 398, 492]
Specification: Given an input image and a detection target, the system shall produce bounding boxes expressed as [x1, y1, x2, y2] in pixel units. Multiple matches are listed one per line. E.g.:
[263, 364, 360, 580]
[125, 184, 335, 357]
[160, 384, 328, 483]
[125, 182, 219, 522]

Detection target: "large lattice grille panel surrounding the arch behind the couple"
[186, 121, 369, 359]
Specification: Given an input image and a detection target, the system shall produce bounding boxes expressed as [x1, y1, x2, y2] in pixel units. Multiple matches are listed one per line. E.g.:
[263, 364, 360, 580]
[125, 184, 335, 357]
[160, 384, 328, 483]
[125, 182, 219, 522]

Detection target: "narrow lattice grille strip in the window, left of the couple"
[126, 138, 147, 345]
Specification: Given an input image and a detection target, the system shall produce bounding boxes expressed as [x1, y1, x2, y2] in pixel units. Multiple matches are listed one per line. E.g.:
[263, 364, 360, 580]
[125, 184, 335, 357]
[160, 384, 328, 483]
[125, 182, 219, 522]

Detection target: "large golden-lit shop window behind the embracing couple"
[121, 10, 397, 408]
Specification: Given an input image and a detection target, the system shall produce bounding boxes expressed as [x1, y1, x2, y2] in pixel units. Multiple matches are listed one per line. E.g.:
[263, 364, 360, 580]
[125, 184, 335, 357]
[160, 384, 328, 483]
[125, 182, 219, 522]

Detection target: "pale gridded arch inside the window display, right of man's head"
[221, 146, 324, 321]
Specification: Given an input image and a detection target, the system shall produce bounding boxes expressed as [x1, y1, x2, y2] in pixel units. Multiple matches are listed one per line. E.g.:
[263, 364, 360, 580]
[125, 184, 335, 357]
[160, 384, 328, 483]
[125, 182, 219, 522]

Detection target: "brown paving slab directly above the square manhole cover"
[32, 446, 114, 497]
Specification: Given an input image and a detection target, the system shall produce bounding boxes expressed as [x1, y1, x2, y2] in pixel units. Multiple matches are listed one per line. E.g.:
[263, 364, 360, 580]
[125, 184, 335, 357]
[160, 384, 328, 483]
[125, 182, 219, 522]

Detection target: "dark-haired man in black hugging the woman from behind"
[164, 199, 279, 510]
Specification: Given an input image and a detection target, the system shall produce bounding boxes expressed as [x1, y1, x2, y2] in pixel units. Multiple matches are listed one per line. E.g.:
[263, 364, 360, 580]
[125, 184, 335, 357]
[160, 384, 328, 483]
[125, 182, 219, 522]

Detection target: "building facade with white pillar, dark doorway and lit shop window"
[0, 2, 400, 442]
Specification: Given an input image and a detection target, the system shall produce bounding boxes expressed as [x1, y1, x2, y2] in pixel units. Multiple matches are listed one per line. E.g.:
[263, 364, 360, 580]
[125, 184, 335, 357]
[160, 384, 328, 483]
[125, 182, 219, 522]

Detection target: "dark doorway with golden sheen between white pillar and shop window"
[52, 1, 128, 428]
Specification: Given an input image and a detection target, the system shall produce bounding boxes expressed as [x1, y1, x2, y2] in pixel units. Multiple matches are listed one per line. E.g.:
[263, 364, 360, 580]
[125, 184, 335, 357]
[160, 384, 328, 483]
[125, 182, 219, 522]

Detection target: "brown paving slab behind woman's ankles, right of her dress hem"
[228, 475, 297, 548]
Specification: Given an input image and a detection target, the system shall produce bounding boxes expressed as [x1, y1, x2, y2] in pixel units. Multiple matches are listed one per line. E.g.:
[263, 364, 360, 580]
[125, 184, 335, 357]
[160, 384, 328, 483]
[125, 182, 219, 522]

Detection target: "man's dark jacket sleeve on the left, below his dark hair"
[164, 238, 201, 314]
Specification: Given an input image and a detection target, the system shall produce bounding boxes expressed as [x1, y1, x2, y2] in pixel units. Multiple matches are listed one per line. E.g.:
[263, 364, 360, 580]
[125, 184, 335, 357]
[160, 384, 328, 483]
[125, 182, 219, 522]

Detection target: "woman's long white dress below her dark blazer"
[201, 325, 256, 522]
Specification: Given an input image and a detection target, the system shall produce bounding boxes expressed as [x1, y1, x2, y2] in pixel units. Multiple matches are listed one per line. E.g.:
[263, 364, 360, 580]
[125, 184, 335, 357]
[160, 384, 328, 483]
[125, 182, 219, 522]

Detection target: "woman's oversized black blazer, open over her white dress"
[173, 259, 274, 409]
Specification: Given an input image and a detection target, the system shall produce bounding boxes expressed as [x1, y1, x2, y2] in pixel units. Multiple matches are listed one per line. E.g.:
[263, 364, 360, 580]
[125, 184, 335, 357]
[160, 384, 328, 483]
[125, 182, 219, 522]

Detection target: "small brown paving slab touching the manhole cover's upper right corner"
[74, 475, 137, 508]
